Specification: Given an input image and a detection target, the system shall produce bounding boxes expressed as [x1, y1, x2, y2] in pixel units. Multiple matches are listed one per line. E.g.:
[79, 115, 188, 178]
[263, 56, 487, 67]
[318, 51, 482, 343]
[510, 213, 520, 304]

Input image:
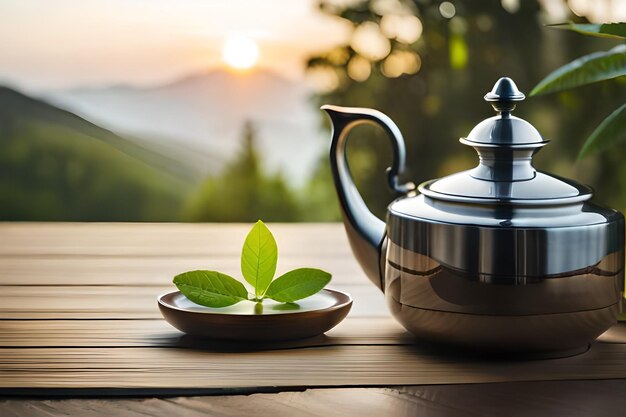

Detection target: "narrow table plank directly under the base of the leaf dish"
[0, 317, 414, 348]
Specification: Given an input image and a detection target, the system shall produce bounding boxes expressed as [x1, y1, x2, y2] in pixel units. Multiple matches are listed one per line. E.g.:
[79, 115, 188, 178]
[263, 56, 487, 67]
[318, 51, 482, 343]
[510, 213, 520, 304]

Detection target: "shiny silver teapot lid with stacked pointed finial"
[419, 77, 592, 205]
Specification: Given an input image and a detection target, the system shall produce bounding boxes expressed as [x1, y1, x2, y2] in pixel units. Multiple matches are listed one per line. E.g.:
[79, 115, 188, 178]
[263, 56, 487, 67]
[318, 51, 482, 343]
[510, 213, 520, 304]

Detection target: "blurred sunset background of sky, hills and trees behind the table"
[0, 0, 626, 222]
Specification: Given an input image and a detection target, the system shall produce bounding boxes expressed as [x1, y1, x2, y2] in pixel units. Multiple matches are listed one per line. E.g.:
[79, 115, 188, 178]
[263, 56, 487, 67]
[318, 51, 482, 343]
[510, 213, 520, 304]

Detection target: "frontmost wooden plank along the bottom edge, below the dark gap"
[0, 380, 626, 417]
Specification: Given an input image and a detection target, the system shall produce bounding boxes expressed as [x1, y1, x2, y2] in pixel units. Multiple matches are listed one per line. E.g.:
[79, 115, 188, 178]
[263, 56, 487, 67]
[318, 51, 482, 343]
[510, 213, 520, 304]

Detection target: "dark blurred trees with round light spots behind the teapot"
[308, 0, 626, 216]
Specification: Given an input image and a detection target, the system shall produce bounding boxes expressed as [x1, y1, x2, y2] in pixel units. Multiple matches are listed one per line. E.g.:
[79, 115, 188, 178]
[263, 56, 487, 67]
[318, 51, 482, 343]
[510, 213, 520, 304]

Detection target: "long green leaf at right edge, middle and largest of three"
[530, 45, 626, 96]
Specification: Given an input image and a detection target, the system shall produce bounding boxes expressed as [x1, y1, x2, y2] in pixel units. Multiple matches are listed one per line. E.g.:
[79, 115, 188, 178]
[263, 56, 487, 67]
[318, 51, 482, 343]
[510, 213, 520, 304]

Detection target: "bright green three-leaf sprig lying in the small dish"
[168, 220, 331, 308]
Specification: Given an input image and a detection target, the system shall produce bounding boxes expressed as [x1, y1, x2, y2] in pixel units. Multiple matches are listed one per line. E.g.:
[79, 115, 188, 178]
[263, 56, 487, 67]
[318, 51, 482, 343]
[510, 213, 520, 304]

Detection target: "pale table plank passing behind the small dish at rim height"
[0, 285, 389, 319]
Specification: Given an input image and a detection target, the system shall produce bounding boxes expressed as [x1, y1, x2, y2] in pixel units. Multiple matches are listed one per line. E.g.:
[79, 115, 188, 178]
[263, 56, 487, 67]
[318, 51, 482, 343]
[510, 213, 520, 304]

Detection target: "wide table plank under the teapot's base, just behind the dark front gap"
[0, 343, 626, 393]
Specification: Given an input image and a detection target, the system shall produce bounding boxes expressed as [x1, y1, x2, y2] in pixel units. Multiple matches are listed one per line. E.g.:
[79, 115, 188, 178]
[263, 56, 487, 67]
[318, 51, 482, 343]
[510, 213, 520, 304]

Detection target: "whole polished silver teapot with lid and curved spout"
[322, 77, 624, 357]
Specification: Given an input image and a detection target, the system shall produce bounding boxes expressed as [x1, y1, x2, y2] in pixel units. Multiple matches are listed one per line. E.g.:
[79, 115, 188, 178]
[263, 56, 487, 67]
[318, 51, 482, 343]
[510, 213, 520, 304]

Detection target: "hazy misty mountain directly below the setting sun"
[44, 70, 328, 183]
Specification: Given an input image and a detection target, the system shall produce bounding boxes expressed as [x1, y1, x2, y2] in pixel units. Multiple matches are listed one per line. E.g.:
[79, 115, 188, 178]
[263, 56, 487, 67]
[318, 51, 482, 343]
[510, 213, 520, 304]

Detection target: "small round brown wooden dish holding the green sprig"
[158, 289, 352, 340]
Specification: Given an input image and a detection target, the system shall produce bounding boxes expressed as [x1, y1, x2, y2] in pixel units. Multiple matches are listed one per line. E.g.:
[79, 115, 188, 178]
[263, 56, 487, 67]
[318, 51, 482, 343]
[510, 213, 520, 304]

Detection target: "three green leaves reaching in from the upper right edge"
[531, 23, 626, 159]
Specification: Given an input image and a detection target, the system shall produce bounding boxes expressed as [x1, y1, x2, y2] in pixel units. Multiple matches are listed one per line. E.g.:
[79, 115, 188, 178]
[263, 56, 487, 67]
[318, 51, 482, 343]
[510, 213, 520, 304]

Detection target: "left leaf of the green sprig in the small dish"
[174, 271, 248, 307]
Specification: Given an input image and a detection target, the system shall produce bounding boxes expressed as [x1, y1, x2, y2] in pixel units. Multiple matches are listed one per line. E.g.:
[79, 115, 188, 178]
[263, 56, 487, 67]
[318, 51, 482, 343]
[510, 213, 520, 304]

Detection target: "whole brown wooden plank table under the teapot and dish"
[0, 223, 626, 417]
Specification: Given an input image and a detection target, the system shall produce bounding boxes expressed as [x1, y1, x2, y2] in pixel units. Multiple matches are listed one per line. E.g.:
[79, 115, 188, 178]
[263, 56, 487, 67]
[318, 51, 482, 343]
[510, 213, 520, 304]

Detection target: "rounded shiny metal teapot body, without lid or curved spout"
[383, 194, 624, 356]
